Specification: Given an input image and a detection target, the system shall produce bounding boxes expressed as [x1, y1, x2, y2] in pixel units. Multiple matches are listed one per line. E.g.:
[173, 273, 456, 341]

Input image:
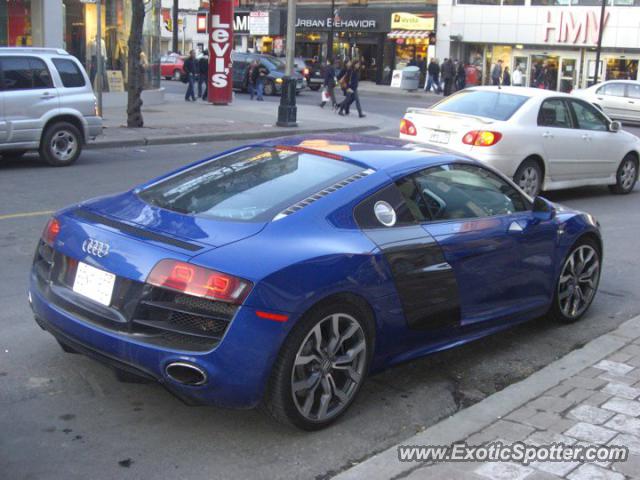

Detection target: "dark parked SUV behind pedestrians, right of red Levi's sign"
[231, 52, 306, 96]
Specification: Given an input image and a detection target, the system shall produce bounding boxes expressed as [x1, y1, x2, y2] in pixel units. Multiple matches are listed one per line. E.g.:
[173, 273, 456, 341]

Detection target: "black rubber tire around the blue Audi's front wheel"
[549, 238, 602, 323]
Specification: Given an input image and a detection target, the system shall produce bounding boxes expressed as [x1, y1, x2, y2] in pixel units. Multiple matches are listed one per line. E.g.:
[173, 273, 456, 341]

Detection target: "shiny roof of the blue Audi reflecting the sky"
[259, 134, 469, 177]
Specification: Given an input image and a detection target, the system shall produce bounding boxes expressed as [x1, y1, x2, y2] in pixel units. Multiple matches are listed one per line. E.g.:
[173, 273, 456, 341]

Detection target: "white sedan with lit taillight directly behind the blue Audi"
[400, 87, 640, 196]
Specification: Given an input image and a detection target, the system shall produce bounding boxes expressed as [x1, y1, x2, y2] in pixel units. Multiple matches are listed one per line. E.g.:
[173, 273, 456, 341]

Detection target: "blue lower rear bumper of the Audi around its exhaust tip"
[30, 274, 284, 408]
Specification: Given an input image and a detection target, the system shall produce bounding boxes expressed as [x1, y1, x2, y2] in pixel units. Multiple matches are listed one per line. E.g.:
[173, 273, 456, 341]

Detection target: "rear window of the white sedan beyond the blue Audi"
[433, 90, 529, 120]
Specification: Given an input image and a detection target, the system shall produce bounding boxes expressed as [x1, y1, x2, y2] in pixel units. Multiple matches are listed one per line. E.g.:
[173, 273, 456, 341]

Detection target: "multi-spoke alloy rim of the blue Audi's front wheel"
[558, 245, 600, 318]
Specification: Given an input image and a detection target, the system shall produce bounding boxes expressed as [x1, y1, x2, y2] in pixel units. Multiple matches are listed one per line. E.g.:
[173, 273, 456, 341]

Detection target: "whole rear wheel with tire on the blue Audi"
[264, 303, 373, 430]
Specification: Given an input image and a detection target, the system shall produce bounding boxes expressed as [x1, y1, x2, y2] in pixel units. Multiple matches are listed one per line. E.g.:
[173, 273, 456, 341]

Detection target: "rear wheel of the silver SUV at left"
[39, 122, 82, 167]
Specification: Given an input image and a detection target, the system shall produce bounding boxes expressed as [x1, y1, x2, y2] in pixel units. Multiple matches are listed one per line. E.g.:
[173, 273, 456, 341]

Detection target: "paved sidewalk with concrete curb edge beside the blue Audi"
[334, 316, 640, 480]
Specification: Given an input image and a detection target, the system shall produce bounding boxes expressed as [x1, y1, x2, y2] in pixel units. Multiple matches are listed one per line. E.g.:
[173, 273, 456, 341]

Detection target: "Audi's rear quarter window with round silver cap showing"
[353, 184, 421, 229]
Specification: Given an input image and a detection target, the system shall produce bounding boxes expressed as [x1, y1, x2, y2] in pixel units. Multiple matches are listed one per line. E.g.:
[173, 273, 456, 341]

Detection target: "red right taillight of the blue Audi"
[147, 260, 251, 304]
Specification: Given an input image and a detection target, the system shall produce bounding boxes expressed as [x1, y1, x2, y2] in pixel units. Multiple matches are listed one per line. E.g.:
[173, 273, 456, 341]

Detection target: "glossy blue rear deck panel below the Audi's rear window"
[81, 191, 266, 247]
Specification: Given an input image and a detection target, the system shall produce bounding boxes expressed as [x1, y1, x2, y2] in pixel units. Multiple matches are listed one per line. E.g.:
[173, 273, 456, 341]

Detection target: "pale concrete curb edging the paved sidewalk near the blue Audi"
[332, 315, 640, 480]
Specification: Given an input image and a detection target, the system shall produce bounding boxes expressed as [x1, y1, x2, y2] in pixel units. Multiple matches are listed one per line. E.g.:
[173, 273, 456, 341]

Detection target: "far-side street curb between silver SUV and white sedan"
[85, 125, 380, 150]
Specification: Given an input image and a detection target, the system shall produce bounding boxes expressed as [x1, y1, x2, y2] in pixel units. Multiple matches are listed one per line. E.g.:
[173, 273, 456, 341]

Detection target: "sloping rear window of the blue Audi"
[139, 147, 362, 221]
